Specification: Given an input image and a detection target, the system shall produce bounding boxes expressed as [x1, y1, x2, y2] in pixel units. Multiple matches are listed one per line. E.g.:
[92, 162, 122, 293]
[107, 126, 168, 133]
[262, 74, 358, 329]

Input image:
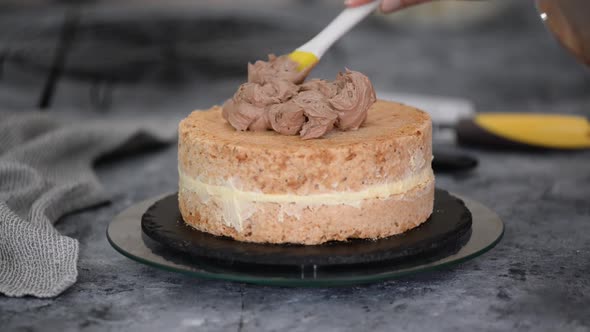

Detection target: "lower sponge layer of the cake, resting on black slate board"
[178, 179, 434, 245]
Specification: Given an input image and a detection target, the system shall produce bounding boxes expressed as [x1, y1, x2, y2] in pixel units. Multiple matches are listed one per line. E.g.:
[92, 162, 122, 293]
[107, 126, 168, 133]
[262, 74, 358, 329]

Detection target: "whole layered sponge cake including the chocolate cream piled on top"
[178, 55, 434, 245]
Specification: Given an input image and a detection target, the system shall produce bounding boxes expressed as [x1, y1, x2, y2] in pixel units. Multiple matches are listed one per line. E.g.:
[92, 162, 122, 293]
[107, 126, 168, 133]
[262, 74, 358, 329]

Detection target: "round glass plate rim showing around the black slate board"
[107, 194, 504, 287]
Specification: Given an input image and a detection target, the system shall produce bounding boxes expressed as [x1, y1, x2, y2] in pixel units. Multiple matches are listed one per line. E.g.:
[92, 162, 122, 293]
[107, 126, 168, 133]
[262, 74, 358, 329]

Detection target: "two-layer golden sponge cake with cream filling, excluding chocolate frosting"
[178, 101, 434, 244]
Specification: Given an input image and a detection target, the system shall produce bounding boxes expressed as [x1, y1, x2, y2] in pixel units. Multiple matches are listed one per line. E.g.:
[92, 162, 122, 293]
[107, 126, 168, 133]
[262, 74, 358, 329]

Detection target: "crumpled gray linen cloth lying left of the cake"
[0, 112, 177, 297]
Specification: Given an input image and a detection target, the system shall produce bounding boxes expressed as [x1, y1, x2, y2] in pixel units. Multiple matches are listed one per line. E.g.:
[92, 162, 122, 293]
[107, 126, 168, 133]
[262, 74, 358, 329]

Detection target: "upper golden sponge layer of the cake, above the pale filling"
[178, 101, 432, 195]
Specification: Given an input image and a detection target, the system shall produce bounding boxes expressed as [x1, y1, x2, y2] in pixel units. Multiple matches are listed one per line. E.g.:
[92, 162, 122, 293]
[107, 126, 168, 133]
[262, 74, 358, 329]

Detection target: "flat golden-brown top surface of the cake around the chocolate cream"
[180, 100, 430, 150]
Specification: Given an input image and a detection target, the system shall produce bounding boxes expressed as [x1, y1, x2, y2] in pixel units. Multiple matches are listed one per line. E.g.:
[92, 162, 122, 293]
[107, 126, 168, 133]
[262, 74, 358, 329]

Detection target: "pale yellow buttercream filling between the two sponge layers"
[178, 167, 434, 231]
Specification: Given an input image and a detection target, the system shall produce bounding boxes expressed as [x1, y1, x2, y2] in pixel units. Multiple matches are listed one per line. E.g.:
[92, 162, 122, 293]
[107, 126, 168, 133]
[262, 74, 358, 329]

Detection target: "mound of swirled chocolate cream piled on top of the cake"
[222, 55, 376, 139]
